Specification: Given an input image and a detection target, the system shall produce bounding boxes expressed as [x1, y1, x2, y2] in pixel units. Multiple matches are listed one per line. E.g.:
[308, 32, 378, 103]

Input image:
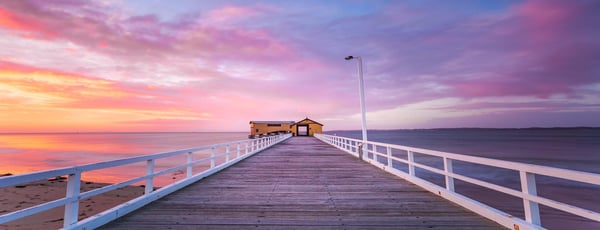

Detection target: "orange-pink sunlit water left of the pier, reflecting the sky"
[0, 133, 246, 186]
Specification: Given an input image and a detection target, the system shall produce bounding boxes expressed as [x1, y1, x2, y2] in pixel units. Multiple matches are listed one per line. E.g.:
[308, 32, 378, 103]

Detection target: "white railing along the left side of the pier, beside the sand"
[0, 134, 292, 229]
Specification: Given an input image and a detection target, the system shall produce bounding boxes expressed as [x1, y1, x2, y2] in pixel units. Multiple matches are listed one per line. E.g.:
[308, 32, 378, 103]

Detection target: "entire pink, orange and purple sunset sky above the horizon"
[0, 0, 600, 133]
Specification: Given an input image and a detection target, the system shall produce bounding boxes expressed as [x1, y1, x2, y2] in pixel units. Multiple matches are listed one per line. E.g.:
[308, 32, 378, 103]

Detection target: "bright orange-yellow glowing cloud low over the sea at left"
[0, 63, 211, 132]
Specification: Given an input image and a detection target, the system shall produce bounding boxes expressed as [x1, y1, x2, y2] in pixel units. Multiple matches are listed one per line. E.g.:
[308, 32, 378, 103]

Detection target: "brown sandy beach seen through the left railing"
[0, 174, 144, 229]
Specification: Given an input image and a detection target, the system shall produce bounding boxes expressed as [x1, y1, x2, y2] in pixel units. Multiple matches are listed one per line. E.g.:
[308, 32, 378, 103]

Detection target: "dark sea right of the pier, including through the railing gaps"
[326, 128, 600, 229]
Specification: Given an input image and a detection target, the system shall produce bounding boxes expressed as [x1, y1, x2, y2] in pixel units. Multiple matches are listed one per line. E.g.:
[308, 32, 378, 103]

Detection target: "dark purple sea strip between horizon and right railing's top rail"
[326, 128, 600, 173]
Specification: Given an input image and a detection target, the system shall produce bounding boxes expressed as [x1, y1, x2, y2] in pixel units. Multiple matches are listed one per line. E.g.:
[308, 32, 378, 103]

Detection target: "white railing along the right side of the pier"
[315, 134, 600, 229]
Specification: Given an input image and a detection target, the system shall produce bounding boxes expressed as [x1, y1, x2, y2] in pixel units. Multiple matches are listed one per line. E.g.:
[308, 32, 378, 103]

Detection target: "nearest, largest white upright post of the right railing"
[519, 171, 541, 226]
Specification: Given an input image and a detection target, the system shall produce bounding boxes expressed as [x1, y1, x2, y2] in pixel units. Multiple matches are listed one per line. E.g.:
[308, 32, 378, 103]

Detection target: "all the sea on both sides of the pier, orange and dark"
[0, 128, 600, 229]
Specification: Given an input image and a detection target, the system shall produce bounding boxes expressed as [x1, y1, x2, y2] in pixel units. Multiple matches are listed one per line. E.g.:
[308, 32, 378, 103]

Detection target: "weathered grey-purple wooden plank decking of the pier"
[104, 137, 502, 229]
